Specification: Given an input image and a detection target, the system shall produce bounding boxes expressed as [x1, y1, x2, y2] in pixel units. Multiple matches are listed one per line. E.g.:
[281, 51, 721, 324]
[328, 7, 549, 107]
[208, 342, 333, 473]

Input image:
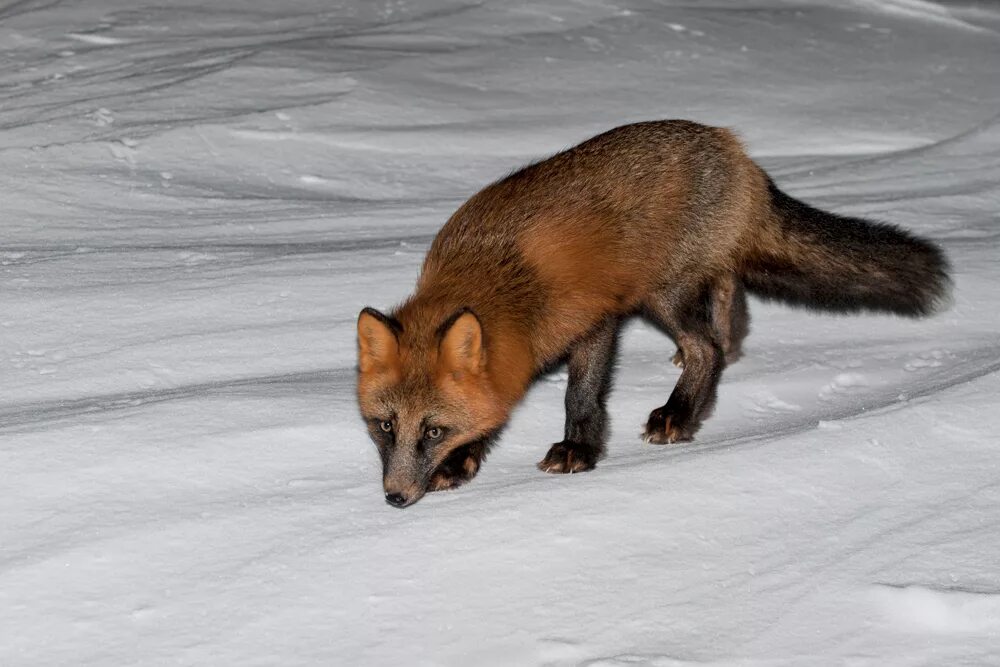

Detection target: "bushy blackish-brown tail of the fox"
[743, 179, 950, 317]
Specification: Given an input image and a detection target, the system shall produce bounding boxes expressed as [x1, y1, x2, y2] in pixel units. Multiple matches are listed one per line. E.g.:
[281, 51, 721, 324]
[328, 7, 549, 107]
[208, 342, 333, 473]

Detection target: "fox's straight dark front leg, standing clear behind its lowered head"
[538, 317, 621, 473]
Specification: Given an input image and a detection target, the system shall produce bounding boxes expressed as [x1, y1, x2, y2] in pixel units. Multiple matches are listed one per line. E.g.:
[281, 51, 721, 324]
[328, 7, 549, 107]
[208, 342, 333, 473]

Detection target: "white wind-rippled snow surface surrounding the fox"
[0, 0, 1000, 666]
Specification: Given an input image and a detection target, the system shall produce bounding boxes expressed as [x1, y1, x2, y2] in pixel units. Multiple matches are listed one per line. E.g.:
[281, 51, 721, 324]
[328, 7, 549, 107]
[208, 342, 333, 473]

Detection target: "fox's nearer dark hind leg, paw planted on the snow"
[644, 288, 726, 444]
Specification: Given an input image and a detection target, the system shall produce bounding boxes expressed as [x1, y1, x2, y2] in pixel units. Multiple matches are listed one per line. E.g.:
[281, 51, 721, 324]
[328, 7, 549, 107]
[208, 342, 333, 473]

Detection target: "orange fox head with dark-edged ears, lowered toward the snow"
[358, 308, 507, 507]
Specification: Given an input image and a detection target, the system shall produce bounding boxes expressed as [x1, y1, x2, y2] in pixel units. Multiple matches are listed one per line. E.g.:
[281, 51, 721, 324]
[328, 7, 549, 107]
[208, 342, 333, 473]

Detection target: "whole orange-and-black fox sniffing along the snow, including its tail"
[357, 120, 950, 508]
